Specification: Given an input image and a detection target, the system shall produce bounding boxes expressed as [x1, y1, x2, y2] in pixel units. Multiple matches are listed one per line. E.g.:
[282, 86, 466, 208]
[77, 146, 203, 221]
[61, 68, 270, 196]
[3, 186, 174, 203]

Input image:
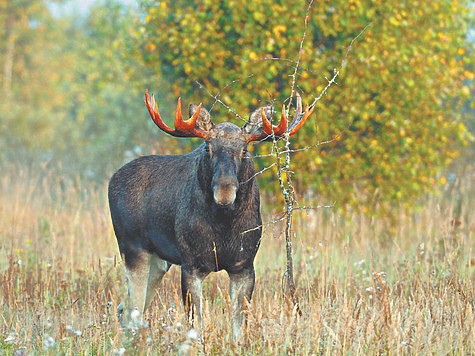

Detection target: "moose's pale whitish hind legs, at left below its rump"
[117, 252, 170, 322]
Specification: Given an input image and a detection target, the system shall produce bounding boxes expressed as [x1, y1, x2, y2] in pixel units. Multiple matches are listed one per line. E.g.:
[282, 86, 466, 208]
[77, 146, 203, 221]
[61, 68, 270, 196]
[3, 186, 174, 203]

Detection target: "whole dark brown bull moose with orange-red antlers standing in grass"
[109, 91, 314, 339]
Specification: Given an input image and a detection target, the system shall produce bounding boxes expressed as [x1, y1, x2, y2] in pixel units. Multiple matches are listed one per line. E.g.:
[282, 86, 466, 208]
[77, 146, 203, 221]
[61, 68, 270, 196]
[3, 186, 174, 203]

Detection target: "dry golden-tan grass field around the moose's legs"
[0, 167, 475, 355]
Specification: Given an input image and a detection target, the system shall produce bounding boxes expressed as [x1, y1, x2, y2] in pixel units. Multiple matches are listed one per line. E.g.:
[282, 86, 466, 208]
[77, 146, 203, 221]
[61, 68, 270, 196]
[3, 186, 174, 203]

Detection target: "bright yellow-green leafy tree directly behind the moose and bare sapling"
[139, 0, 473, 210]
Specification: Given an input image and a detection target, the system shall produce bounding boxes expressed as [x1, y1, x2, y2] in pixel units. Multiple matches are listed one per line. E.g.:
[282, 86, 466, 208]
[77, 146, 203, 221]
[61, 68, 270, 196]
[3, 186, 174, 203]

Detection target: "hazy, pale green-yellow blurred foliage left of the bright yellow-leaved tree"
[0, 0, 162, 180]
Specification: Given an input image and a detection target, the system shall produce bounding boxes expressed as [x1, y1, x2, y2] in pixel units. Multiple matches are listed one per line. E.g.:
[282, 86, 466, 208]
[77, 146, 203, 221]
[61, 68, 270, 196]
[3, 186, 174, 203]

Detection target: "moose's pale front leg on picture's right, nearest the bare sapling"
[228, 266, 255, 340]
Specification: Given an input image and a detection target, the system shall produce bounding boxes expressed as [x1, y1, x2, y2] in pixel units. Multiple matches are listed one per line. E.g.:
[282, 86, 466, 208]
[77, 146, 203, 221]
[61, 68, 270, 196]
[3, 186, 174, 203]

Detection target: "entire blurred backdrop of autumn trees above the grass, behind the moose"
[0, 0, 474, 214]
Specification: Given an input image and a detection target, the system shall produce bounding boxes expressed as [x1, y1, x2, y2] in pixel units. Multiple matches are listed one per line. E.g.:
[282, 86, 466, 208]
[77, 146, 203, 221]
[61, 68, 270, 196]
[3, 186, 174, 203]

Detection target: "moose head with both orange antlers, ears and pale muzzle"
[145, 91, 315, 206]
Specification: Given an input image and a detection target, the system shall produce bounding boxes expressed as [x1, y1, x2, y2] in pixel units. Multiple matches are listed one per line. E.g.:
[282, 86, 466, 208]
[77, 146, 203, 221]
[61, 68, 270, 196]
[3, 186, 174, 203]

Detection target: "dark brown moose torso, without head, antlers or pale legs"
[109, 145, 261, 274]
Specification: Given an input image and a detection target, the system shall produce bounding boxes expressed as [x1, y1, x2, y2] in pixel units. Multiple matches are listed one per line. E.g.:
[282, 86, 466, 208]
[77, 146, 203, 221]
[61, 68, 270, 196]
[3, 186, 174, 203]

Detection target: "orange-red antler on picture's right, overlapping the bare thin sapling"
[248, 93, 315, 142]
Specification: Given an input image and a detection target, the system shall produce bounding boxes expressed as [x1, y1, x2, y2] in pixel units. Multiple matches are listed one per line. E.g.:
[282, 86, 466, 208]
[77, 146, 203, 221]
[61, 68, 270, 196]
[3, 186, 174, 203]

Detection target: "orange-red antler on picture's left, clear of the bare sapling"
[145, 90, 207, 138]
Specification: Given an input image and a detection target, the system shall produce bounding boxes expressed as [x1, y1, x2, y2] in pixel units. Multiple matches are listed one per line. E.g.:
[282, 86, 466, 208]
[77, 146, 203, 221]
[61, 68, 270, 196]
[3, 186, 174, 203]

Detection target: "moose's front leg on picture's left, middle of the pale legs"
[181, 266, 206, 329]
